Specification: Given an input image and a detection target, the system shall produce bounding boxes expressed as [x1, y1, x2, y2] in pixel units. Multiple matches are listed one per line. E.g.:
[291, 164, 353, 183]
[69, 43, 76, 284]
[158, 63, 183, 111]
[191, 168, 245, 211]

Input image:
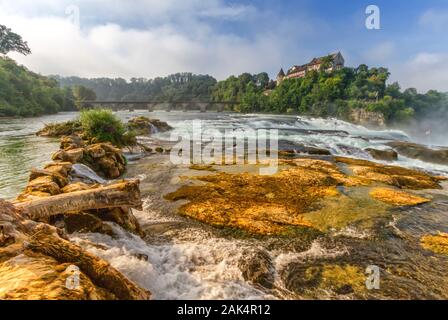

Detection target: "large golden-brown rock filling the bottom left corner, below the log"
[0, 200, 151, 300]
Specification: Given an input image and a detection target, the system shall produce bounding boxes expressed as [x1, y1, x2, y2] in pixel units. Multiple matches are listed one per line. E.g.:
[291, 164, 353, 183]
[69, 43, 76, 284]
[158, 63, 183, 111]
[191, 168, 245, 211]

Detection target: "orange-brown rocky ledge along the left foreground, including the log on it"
[0, 117, 175, 300]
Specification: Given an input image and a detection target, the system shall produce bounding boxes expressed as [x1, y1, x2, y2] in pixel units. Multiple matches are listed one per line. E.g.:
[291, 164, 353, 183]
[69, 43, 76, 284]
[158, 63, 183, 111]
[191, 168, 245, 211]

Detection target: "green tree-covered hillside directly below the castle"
[212, 65, 448, 123]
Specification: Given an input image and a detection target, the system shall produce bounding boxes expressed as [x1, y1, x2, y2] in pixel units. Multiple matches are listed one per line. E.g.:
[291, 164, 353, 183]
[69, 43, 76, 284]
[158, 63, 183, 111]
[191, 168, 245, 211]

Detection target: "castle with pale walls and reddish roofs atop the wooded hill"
[277, 52, 345, 84]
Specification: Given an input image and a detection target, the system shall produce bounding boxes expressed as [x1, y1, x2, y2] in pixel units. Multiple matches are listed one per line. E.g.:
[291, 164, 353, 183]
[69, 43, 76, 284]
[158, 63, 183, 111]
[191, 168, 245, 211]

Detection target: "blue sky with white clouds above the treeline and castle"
[0, 0, 448, 92]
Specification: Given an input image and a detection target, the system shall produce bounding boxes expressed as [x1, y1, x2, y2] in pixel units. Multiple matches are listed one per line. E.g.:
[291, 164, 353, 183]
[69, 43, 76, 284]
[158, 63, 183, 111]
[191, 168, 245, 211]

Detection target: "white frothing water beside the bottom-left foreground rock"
[72, 222, 274, 300]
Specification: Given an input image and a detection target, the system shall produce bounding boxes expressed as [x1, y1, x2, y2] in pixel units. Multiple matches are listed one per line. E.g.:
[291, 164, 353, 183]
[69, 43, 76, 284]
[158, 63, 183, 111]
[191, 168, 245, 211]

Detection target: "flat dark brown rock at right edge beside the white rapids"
[388, 141, 448, 165]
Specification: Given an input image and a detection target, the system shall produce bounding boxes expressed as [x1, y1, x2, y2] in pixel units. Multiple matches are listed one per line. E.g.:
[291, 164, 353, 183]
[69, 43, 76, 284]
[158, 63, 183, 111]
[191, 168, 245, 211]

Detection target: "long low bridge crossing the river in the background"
[81, 100, 238, 112]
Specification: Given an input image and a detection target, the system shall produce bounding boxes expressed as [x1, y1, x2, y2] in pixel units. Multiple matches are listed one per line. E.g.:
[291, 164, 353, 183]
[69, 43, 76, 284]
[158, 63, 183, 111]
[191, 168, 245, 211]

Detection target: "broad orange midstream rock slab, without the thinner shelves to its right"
[165, 159, 350, 235]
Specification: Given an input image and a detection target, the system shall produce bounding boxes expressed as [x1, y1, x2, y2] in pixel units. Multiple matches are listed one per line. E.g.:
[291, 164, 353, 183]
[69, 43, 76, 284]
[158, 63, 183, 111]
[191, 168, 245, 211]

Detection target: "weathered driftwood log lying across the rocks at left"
[14, 180, 142, 220]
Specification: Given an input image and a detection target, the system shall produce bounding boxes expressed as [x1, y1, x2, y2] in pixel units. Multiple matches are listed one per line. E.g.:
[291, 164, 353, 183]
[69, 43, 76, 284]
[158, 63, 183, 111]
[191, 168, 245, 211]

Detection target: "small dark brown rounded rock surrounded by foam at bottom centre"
[238, 250, 275, 289]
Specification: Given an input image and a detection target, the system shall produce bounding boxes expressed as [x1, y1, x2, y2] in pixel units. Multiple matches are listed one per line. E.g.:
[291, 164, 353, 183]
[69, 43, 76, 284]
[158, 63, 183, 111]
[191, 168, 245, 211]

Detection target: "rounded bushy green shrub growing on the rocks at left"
[79, 109, 126, 146]
